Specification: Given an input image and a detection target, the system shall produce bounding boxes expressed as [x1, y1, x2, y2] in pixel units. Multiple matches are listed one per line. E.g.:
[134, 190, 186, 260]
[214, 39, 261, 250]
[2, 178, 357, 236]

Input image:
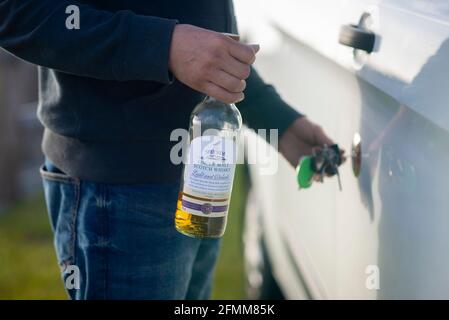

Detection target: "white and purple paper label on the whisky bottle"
[181, 136, 237, 217]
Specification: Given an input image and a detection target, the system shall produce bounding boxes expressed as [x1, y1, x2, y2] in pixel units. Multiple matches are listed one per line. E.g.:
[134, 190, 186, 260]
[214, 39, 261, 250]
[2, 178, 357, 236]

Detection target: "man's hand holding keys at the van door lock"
[279, 117, 345, 167]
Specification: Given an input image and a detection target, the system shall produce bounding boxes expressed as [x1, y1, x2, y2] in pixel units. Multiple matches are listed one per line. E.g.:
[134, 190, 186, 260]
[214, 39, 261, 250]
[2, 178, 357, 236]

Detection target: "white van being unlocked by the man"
[236, 0, 449, 299]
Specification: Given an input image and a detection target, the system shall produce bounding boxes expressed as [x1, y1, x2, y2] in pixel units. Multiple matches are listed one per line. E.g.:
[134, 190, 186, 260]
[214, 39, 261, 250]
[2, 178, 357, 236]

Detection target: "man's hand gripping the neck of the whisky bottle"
[169, 24, 259, 103]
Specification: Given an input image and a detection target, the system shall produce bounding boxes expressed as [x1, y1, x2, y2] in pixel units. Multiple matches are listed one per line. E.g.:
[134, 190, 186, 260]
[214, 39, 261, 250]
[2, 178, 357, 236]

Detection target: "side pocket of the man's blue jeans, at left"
[40, 160, 80, 266]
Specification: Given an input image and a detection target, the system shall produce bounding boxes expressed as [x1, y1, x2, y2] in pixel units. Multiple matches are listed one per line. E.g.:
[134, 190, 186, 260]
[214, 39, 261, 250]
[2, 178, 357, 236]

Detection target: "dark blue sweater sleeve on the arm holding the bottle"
[0, 0, 177, 83]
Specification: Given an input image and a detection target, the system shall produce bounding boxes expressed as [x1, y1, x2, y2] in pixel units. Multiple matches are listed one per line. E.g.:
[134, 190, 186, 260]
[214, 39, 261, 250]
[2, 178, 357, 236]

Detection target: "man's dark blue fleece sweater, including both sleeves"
[0, 0, 299, 184]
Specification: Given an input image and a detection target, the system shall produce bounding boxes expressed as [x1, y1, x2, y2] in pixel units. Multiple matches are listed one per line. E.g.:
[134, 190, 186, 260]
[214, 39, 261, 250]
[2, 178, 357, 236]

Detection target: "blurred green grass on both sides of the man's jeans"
[0, 168, 247, 299]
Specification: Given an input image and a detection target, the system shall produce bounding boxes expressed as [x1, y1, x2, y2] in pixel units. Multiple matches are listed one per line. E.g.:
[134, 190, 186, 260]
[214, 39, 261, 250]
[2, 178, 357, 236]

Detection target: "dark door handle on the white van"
[338, 24, 376, 53]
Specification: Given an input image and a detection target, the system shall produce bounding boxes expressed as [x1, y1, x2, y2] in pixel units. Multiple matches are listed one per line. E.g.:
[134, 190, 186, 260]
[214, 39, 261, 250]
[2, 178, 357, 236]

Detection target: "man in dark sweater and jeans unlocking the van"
[0, 0, 332, 299]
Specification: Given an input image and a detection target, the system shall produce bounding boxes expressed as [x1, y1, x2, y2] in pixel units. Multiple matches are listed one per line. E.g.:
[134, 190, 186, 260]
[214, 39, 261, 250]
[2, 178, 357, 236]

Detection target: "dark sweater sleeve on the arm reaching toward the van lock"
[237, 68, 302, 137]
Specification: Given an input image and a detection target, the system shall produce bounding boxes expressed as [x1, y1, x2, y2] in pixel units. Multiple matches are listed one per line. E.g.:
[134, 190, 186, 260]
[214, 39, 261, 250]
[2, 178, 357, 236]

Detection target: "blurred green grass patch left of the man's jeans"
[0, 191, 66, 299]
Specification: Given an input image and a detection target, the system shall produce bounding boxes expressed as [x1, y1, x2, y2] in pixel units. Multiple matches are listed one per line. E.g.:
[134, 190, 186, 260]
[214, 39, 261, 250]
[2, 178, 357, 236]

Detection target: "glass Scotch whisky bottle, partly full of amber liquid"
[175, 97, 242, 238]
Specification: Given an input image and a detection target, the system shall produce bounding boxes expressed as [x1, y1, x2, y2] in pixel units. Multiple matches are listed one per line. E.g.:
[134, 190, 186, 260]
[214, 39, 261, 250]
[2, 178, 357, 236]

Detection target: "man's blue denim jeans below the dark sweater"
[41, 160, 220, 299]
